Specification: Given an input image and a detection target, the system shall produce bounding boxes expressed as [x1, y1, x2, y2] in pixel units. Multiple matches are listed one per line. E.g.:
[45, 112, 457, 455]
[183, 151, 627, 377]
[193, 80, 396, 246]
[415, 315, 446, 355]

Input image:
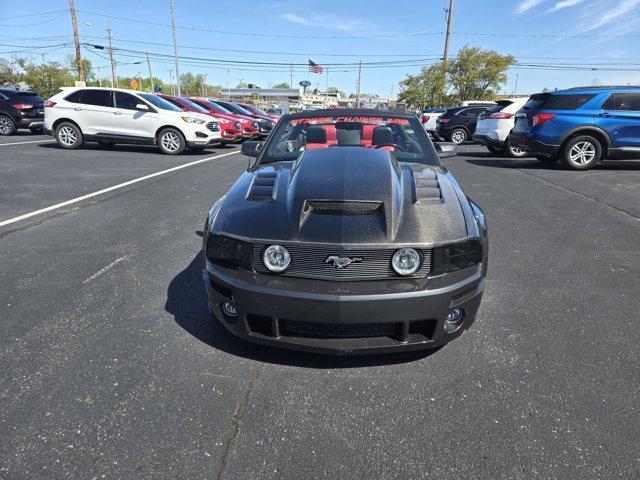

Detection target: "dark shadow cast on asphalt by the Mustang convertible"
[165, 252, 437, 369]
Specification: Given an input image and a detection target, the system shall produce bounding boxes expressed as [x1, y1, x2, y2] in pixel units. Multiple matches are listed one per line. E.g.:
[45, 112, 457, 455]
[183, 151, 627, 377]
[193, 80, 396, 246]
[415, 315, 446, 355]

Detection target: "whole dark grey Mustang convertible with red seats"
[203, 110, 488, 354]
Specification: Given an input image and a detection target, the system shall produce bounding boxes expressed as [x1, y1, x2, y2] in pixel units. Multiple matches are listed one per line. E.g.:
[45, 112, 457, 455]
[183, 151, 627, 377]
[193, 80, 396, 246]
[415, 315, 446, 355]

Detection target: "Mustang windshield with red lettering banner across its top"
[260, 112, 439, 165]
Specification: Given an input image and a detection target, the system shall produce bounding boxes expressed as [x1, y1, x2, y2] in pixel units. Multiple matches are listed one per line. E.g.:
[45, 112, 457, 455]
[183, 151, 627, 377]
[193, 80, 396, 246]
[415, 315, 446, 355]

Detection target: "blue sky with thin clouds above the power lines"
[0, 0, 640, 96]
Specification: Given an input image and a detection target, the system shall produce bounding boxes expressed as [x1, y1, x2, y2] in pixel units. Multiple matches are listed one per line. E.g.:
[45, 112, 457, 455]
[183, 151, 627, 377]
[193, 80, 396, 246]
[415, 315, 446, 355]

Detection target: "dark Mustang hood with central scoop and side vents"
[213, 147, 467, 246]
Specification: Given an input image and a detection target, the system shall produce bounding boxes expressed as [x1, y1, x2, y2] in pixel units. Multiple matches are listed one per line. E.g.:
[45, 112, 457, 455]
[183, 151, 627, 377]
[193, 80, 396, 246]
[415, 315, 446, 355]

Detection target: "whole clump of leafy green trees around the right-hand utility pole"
[398, 46, 516, 108]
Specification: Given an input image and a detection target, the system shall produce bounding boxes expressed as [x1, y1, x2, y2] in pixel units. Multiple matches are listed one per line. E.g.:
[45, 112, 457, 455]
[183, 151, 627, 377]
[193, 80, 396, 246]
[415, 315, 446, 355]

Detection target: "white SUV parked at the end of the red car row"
[44, 87, 221, 155]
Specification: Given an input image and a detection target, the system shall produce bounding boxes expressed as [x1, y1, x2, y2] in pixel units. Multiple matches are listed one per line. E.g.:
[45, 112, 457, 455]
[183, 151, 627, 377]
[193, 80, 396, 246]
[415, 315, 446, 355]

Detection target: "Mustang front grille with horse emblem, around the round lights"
[253, 243, 431, 280]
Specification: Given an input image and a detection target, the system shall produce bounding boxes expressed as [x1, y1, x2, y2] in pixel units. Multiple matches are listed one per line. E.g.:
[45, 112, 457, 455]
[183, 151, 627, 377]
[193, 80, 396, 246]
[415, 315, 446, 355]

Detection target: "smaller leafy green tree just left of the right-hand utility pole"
[398, 62, 450, 108]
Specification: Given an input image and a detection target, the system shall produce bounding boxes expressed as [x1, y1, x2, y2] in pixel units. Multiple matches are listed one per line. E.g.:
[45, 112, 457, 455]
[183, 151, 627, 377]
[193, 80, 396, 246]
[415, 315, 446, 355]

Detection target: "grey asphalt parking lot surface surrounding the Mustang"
[0, 135, 640, 480]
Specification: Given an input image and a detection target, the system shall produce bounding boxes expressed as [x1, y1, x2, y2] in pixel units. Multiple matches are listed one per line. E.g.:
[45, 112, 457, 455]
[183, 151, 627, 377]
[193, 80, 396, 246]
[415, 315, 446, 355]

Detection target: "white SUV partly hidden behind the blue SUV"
[473, 98, 529, 158]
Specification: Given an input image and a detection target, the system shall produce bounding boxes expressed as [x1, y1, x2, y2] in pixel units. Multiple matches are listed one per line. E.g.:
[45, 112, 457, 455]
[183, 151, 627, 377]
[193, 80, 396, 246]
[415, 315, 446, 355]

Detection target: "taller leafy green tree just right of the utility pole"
[447, 46, 516, 101]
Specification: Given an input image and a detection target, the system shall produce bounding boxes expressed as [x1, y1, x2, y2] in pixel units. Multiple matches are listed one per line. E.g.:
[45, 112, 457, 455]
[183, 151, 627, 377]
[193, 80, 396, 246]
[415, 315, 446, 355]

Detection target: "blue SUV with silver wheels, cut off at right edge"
[509, 87, 640, 170]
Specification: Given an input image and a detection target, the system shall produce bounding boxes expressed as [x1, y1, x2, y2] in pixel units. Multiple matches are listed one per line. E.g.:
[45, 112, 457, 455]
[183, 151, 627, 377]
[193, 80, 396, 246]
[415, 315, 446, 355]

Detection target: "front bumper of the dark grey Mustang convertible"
[203, 261, 484, 355]
